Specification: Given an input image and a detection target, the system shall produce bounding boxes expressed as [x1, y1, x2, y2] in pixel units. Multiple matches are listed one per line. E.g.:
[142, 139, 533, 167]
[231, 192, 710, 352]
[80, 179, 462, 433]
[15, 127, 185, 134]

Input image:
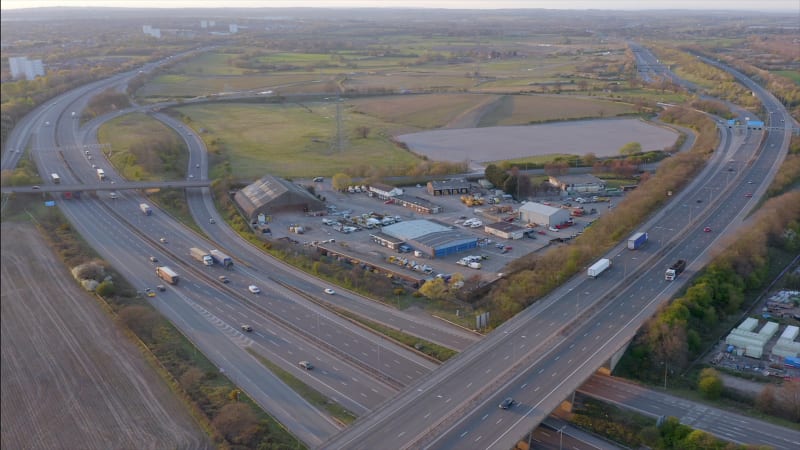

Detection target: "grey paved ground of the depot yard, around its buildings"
[268, 179, 617, 283]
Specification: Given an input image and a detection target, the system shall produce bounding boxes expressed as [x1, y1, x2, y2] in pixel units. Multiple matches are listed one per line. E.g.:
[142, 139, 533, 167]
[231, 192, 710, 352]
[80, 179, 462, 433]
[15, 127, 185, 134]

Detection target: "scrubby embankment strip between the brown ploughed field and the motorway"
[3, 196, 304, 449]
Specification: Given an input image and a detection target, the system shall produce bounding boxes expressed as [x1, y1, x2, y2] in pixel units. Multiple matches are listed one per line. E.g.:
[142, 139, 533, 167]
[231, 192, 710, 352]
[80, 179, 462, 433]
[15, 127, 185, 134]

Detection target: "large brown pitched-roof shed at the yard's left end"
[233, 175, 325, 223]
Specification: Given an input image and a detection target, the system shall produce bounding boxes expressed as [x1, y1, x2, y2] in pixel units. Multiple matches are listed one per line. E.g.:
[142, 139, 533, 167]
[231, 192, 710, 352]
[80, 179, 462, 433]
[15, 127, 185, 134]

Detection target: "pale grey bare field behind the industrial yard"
[397, 119, 678, 163]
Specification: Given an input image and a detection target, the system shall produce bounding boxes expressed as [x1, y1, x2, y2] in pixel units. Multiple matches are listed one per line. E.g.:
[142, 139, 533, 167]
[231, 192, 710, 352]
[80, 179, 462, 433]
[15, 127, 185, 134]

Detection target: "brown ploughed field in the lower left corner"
[0, 223, 214, 450]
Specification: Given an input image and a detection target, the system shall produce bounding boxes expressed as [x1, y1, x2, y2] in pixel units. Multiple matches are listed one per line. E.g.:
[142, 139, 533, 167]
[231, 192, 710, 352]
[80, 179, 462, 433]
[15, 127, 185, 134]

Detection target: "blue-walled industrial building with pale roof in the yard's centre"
[380, 219, 478, 258]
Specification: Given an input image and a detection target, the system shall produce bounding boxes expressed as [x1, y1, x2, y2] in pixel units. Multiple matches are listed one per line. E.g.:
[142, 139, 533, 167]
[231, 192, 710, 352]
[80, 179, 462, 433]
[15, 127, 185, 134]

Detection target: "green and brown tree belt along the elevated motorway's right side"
[617, 191, 800, 396]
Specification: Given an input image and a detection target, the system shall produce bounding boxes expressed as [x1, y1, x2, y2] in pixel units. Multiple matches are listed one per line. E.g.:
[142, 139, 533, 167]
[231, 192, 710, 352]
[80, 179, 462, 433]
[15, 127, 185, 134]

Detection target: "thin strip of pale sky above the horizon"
[0, 0, 800, 14]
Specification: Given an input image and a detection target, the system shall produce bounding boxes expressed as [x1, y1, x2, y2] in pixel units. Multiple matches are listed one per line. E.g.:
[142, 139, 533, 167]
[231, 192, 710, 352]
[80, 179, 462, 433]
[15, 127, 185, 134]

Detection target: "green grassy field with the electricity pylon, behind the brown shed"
[173, 103, 416, 179]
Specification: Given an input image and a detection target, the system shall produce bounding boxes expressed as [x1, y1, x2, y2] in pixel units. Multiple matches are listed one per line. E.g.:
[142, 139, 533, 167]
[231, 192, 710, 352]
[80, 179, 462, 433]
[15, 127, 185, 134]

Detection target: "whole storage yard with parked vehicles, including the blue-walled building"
[264, 180, 612, 284]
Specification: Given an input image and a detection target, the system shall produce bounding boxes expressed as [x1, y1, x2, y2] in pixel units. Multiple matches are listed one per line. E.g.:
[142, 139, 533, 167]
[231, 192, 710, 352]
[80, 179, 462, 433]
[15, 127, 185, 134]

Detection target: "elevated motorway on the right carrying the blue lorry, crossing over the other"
[323, 50, 800, 449]
